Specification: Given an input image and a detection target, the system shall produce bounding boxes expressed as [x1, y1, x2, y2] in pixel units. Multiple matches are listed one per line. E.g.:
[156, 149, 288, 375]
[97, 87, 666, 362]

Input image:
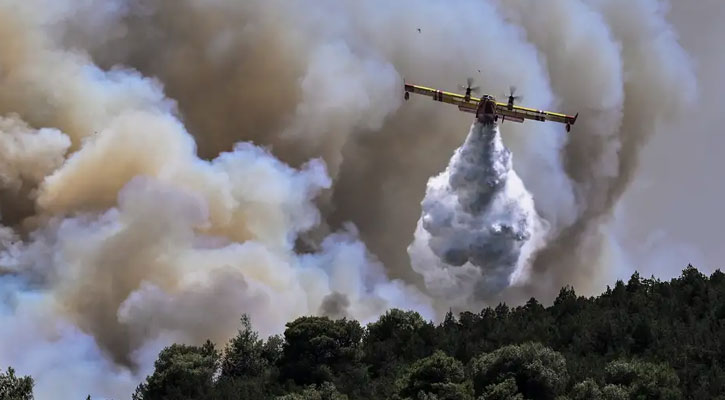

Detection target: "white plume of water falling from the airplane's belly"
[408, 121, 546, 307]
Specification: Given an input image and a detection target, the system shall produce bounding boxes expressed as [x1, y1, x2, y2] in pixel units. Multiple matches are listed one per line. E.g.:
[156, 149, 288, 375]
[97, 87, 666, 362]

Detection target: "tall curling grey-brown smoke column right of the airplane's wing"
[492, 0, 696, 299]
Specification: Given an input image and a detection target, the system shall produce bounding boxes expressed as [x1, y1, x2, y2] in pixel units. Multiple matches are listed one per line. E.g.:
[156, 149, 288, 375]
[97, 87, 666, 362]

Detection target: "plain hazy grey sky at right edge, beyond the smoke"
[613, 0, 725, 279]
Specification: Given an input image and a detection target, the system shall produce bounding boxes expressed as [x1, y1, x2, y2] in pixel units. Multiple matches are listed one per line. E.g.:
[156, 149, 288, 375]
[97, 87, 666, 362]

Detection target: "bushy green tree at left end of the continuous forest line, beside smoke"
[133, 340, 220, 400]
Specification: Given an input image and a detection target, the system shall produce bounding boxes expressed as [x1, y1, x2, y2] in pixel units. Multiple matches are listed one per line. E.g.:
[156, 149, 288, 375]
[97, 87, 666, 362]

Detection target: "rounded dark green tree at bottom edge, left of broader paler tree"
[398, 350, 473, 400]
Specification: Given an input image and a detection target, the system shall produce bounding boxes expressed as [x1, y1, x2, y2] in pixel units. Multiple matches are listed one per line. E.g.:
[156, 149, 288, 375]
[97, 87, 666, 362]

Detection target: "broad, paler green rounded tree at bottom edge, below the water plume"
[471, 343, 568, 399]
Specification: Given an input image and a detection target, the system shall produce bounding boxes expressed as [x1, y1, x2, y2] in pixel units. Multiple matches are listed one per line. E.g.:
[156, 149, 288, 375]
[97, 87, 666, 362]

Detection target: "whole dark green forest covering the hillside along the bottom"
[0, 265, 725, 400]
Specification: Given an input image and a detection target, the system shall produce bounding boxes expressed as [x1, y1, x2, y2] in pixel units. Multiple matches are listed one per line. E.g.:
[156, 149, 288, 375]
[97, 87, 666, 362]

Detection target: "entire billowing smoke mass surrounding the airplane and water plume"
[0, 0, 708, 399]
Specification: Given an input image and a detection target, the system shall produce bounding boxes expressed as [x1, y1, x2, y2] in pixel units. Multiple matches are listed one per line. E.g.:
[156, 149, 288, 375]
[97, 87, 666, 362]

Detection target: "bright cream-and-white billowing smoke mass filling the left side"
[0, 1, 435, 399]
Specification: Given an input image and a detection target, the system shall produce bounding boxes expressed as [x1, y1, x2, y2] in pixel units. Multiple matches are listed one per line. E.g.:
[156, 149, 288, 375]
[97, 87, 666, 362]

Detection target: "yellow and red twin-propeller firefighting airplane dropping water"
[405, 78, 579, 132]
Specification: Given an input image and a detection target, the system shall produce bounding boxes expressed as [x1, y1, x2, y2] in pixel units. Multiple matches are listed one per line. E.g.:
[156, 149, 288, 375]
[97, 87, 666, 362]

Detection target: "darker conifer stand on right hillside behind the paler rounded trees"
[437, 266, 725, 398]
